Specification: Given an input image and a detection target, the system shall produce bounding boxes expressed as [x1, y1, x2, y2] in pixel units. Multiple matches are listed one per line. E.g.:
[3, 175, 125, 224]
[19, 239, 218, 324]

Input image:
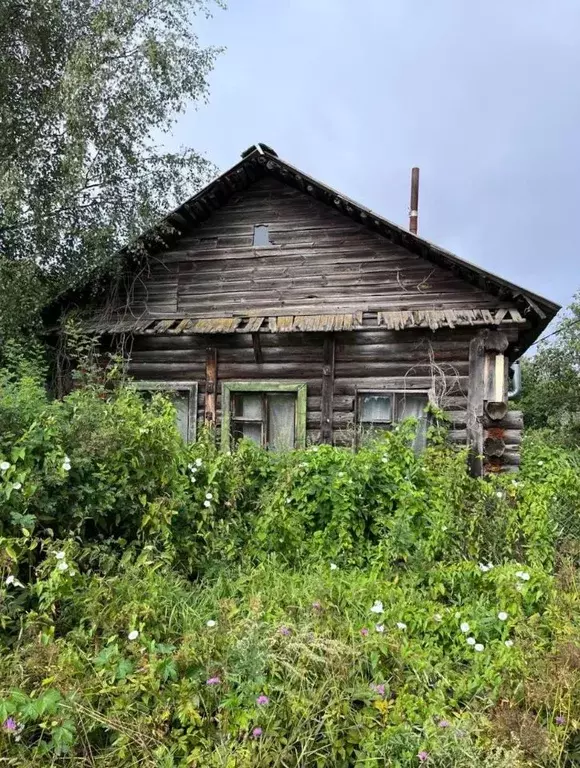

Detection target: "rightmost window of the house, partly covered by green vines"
[357, 391, 429, 452]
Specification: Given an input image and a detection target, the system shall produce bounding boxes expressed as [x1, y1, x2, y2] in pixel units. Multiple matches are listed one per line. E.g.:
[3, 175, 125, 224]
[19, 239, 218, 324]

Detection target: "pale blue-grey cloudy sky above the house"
[171, 0, 580, 316]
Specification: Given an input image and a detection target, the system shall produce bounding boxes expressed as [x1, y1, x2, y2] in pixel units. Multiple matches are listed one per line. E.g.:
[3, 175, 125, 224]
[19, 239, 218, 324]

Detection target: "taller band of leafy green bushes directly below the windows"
[0, 377, 578, 574]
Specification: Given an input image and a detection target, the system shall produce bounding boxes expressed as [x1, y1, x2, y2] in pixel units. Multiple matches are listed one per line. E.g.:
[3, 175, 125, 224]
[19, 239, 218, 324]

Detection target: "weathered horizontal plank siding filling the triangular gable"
[121, 178, 507, 318]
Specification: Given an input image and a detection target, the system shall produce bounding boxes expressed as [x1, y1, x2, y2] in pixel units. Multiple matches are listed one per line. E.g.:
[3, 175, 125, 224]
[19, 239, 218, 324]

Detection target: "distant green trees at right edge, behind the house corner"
[520, 296, 580, 447]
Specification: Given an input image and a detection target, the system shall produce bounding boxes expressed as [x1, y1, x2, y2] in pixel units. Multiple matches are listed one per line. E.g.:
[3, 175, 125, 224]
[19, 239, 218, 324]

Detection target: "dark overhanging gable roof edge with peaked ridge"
[52, 144, 560, 354]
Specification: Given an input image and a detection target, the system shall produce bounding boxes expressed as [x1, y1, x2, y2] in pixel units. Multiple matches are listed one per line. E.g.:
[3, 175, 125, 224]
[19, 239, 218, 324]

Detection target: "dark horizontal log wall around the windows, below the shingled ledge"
[129, 328, 520, 444]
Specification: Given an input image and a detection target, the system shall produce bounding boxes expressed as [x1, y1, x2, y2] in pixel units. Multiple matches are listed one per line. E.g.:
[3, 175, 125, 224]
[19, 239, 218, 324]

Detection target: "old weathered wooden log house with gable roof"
[51, 144, 559, 473]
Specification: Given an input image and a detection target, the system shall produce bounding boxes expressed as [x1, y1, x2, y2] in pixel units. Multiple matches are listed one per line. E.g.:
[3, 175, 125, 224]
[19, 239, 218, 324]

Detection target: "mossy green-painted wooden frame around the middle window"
[221, 381, 307, 451]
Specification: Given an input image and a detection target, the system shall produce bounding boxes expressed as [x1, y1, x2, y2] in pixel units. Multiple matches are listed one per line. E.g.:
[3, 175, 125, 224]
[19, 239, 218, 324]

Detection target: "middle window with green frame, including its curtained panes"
[222, 381, 306, 451]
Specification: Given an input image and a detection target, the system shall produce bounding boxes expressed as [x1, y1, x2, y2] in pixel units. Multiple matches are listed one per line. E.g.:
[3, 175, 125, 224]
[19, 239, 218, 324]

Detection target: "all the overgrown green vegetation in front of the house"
[0, 356, 580, 768]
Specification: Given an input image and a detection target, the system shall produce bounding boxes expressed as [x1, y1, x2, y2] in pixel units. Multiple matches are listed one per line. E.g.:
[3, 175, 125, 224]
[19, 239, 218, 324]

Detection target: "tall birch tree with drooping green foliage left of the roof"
[0, 0, 221, 334]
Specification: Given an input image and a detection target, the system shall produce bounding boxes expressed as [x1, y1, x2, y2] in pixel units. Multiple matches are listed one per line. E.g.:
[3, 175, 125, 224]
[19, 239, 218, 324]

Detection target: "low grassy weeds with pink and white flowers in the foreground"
[0, 548, 580, 768]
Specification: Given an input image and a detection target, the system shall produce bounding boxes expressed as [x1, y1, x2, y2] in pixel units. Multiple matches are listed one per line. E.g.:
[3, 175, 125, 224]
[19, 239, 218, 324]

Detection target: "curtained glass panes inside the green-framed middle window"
[232, 392, 296, 451]
